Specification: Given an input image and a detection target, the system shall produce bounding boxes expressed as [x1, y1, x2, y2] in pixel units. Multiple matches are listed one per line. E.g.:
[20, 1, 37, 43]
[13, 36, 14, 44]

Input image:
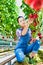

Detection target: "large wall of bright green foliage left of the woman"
[0, 0, 19, 37]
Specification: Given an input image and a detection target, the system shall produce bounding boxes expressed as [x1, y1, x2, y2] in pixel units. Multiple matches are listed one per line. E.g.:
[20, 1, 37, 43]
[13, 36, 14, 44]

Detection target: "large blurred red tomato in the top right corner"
[24, 0, 43, 11]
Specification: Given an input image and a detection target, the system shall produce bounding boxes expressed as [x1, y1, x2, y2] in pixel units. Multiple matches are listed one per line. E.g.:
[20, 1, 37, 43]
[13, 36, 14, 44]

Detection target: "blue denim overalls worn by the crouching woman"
[15, 29, 40, 62]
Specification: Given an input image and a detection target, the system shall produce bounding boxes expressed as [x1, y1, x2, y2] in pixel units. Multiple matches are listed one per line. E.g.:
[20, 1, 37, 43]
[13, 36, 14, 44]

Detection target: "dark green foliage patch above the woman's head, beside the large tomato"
[21, 0, 35, 19]
